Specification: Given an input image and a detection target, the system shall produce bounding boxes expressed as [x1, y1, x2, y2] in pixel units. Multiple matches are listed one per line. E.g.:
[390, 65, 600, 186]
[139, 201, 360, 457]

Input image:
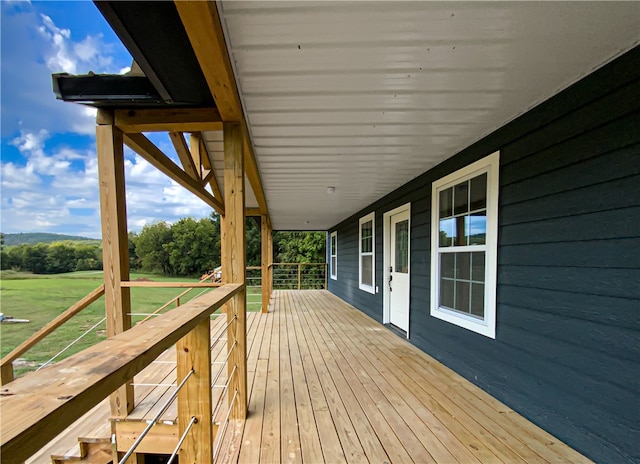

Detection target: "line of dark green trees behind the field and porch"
[0, 213, 326, 276]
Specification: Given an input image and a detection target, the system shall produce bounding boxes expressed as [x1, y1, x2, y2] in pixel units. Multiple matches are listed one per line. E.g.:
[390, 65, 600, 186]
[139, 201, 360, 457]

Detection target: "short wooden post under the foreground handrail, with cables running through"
[176, 317, 213, 464]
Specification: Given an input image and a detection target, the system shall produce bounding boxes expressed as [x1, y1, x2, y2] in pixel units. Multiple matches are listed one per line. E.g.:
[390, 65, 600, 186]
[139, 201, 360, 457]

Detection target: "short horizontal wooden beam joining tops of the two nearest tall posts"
[114, 108, 222, 134]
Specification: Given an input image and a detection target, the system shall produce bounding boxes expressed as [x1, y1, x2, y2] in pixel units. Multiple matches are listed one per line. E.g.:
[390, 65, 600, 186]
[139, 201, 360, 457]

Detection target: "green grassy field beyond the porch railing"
[0, 271, 260, 375]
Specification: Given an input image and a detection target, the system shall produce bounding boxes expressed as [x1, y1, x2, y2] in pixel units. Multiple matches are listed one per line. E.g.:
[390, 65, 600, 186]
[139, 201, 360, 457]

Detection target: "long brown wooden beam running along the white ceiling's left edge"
[175, 1, 269, 214]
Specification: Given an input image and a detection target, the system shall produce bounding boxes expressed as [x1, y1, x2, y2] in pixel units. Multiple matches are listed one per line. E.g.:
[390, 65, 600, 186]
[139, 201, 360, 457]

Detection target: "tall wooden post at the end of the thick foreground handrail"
[224, 123, 247, 419]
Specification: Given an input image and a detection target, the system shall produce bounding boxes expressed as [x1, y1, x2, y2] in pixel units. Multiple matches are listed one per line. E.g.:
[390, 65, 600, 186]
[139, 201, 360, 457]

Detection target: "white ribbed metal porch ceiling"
[219, 1, 640, 230]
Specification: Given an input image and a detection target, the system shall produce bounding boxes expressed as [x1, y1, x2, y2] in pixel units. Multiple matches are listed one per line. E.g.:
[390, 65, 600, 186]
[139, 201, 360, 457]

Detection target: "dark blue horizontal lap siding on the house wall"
[329, 48, 640, 462]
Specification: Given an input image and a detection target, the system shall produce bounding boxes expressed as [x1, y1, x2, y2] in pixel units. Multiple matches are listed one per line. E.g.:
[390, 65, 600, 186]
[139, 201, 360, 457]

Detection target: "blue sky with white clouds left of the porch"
[0, 0, 211, 238]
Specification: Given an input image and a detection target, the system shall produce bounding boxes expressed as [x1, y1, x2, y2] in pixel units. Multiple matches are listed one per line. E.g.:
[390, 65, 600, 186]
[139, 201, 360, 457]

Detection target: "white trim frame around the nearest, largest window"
[431, 152, 500, 339]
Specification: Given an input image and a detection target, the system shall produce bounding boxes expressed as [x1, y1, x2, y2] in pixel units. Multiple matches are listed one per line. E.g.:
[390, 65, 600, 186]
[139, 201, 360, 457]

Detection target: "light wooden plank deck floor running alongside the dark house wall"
[218, 290, 590, 464]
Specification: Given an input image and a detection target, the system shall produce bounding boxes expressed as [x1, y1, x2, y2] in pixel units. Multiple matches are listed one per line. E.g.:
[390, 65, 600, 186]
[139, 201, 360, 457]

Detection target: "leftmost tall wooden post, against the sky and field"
[96, 109, 134, 417]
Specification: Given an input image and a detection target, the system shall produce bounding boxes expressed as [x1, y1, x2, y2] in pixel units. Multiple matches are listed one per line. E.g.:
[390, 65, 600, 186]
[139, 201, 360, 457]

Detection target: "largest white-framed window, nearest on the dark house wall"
[431, 152, 500, 338]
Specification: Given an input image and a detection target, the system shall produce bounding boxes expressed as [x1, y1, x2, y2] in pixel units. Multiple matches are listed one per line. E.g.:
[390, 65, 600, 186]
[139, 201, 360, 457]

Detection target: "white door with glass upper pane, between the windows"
[387, 211, 409, 332]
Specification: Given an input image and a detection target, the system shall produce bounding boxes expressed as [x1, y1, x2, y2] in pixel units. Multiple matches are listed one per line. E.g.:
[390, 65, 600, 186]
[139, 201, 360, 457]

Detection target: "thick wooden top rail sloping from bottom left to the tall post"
[0, 284, 244, 463]
